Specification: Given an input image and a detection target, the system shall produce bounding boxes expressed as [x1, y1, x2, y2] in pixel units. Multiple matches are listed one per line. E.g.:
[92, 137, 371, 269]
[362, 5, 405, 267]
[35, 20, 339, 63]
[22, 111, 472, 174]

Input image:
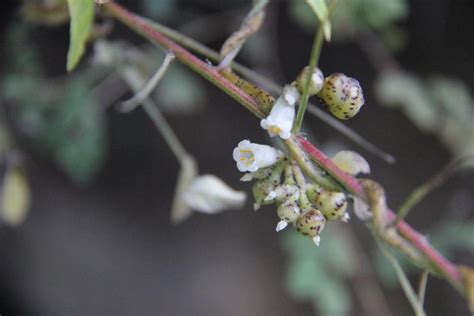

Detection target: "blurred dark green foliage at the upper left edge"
[0, 24, 107, 184]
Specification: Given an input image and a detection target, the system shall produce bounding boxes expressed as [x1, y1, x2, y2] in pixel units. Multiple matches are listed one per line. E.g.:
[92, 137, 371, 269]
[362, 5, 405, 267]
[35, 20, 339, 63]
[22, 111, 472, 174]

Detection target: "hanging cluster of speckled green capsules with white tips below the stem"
[250, 159, 347, 245]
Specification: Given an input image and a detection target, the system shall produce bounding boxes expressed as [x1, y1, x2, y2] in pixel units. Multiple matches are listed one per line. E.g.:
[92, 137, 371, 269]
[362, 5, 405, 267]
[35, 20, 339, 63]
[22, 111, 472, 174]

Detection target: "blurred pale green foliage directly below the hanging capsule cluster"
[283, 227, 356, 316]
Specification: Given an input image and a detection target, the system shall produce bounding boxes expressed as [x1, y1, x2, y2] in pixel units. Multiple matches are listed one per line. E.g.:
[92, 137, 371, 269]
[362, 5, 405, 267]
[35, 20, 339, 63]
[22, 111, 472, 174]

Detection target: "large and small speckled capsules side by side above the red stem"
[296, 66, 365, 120]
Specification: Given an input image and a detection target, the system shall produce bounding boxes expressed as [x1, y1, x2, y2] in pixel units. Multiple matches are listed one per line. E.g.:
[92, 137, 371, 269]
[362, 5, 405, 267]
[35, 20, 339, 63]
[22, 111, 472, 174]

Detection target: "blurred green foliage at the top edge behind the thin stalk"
[289, 0, 409, 48]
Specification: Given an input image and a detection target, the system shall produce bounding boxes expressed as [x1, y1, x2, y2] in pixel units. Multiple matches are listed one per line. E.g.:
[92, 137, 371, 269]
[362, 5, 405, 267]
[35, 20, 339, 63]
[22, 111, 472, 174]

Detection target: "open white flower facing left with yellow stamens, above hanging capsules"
[232, 140, 283, 172]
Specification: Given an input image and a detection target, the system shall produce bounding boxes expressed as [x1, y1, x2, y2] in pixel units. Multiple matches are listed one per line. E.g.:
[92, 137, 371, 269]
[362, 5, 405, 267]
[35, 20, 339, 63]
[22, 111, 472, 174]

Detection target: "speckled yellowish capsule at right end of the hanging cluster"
[314, 189, 347, 221]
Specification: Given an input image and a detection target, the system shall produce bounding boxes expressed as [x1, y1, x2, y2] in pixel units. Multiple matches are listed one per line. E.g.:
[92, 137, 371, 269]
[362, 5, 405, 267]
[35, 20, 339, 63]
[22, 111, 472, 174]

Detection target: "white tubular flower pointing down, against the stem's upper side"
[260, 86, 299, 139]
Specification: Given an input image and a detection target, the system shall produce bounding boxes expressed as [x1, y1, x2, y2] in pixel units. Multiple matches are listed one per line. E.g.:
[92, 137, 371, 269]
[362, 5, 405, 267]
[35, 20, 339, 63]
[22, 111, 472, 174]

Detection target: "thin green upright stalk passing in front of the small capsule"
[292, 25, 324, 135]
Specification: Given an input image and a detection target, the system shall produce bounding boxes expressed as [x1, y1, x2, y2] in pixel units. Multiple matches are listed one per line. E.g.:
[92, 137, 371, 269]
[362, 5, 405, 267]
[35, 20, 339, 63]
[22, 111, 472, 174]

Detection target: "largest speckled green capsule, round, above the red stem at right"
[318, 73, 365, 120]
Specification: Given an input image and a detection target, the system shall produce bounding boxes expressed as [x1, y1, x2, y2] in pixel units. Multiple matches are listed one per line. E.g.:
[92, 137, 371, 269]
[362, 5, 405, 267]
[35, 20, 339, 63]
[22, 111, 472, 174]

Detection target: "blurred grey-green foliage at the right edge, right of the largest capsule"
[375, 72, 474, 167]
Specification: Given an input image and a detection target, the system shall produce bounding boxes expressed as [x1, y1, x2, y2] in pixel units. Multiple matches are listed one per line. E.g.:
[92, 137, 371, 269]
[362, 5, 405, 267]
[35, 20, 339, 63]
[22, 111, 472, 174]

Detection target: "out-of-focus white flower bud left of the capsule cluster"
[183, 174, 246, 214]
